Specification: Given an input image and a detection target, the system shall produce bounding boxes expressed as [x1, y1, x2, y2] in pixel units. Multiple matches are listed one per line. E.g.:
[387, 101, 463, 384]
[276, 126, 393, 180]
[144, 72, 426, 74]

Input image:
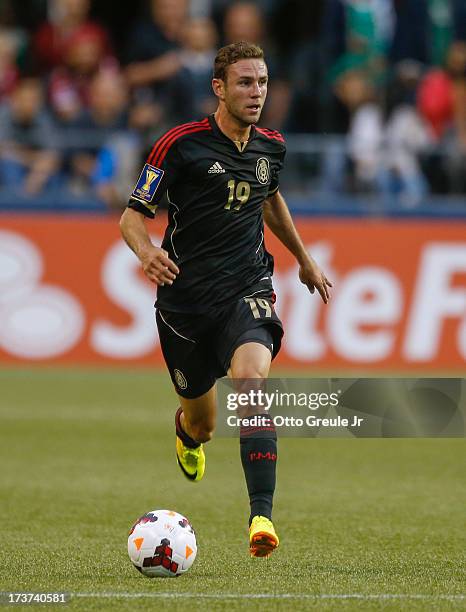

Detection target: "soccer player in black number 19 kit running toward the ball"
[120, 42, 332, 557]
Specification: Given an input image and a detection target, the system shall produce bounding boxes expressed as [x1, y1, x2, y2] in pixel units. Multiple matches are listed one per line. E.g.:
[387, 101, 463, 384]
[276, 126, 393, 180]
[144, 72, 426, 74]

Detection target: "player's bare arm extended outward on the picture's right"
[262, 190, 332, 304]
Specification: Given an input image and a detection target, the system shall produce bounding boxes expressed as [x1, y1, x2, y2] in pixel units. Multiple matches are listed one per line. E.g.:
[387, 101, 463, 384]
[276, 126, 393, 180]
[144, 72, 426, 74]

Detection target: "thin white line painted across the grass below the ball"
[74, 591, 466, 601]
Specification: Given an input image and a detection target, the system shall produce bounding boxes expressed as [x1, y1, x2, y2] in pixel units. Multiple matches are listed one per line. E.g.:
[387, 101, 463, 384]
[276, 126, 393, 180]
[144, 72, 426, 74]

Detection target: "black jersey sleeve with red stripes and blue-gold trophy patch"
[128, 135, 182, 219]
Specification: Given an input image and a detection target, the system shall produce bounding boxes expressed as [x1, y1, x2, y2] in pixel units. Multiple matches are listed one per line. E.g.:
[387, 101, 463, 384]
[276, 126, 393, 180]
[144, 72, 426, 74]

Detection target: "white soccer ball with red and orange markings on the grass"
[128, 510, 197, 578]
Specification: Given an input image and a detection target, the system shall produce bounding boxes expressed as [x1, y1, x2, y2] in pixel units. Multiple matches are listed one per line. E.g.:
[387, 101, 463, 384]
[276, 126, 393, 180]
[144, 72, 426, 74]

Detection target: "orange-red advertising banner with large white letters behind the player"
[0, 215, 466, 375]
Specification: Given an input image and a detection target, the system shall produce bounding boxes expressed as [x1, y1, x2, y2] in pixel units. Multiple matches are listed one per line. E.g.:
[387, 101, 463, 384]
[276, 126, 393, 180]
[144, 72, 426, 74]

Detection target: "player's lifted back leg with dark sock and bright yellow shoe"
[175, 385, 217, 482]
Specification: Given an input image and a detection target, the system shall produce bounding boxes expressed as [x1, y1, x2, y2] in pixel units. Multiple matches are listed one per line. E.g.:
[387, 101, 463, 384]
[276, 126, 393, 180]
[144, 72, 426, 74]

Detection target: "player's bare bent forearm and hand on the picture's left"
[120, 208, 179, 285]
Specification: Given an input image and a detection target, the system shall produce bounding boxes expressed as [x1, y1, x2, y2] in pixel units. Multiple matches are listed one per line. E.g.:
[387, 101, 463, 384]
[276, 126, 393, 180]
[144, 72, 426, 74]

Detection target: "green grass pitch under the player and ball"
[0, 368, 466, 611]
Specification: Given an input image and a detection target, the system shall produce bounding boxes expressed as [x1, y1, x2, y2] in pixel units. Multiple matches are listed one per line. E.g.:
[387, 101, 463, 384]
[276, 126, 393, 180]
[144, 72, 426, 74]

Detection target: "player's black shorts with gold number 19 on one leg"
[155, 293, 283, 399]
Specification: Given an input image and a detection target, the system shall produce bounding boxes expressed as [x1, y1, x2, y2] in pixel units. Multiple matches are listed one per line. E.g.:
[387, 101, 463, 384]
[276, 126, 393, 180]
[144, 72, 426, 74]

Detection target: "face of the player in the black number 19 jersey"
[223, 59, 268, 125]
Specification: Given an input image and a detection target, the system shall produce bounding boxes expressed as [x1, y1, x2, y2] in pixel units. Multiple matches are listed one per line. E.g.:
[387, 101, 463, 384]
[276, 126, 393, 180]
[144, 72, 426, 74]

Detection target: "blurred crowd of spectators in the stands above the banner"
[0, 0, 466, 208]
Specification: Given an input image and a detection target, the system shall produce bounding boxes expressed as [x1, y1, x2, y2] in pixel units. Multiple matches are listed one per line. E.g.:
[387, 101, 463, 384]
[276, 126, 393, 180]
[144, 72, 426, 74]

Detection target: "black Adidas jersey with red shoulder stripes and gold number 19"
[128, 115, 285, 313]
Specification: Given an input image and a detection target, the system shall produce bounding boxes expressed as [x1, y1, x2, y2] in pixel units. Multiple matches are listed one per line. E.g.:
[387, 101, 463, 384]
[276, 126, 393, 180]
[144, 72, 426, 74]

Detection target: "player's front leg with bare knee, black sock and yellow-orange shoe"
[228, 342, 279, 557]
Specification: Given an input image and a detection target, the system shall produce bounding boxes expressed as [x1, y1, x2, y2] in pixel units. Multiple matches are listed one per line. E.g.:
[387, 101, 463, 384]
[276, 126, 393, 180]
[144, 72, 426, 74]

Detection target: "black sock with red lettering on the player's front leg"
[240, 415, 277, 524]
